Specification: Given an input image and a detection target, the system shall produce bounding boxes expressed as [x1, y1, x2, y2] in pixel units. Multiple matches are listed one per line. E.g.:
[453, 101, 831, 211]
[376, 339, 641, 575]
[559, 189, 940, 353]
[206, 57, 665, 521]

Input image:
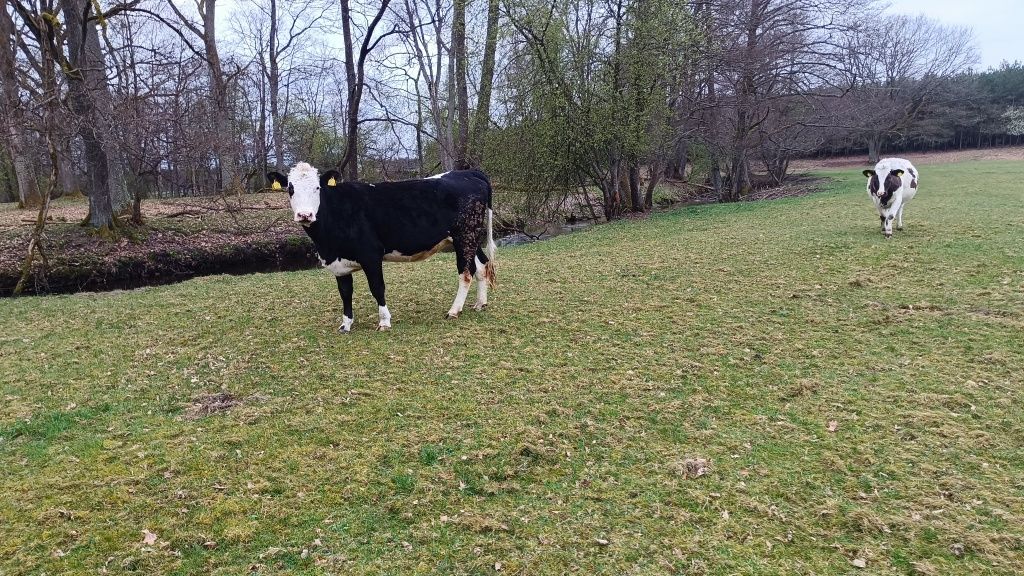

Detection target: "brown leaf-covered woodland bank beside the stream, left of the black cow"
[0, 194, 318, 295]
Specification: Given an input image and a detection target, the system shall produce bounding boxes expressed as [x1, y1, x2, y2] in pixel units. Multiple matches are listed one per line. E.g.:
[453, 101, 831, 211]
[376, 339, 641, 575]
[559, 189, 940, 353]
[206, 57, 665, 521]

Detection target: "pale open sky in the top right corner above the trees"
[889, 0, 1024, 70]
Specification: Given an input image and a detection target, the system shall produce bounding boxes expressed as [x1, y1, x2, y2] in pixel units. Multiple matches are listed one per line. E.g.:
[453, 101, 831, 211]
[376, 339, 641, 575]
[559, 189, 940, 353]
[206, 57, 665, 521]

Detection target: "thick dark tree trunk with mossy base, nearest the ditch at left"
[60, 0, 122, 231]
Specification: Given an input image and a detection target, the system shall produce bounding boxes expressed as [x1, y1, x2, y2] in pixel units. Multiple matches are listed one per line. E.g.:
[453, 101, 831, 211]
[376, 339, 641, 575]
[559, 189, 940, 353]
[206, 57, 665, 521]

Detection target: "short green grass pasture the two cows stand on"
[0, 162, 1024, 576]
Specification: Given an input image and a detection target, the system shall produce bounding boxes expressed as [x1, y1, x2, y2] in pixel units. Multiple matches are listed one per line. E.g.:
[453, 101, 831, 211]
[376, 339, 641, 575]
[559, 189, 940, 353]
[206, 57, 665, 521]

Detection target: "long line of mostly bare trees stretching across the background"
[0, 0, 1024, 230]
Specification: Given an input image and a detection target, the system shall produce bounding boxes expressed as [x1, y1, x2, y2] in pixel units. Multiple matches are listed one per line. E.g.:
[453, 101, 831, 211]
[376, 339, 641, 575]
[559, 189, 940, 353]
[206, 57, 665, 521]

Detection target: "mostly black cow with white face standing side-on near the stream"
[266, 162, 497, 332]
